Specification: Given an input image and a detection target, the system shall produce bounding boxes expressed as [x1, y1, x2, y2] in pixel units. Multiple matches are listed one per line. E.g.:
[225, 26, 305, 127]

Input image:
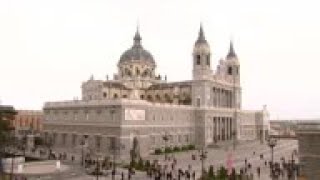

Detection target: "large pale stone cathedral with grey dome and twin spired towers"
[43, 27, 269, 157]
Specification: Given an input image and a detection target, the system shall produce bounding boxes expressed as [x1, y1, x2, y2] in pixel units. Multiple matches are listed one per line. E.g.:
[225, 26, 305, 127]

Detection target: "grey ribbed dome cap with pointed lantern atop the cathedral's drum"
[119, 30, 155, 65]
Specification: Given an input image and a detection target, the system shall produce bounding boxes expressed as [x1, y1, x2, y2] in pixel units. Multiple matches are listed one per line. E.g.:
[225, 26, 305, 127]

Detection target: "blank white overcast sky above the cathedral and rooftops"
[0, 0, 320, 119]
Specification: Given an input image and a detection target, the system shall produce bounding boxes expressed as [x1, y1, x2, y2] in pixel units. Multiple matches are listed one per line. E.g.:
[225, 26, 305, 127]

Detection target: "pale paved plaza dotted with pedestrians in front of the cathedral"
[8, 140, 298, 180]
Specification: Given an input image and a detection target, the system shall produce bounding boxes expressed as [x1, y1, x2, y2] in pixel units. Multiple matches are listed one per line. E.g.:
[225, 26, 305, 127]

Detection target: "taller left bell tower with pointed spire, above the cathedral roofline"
[192, 25, 212, 80]
